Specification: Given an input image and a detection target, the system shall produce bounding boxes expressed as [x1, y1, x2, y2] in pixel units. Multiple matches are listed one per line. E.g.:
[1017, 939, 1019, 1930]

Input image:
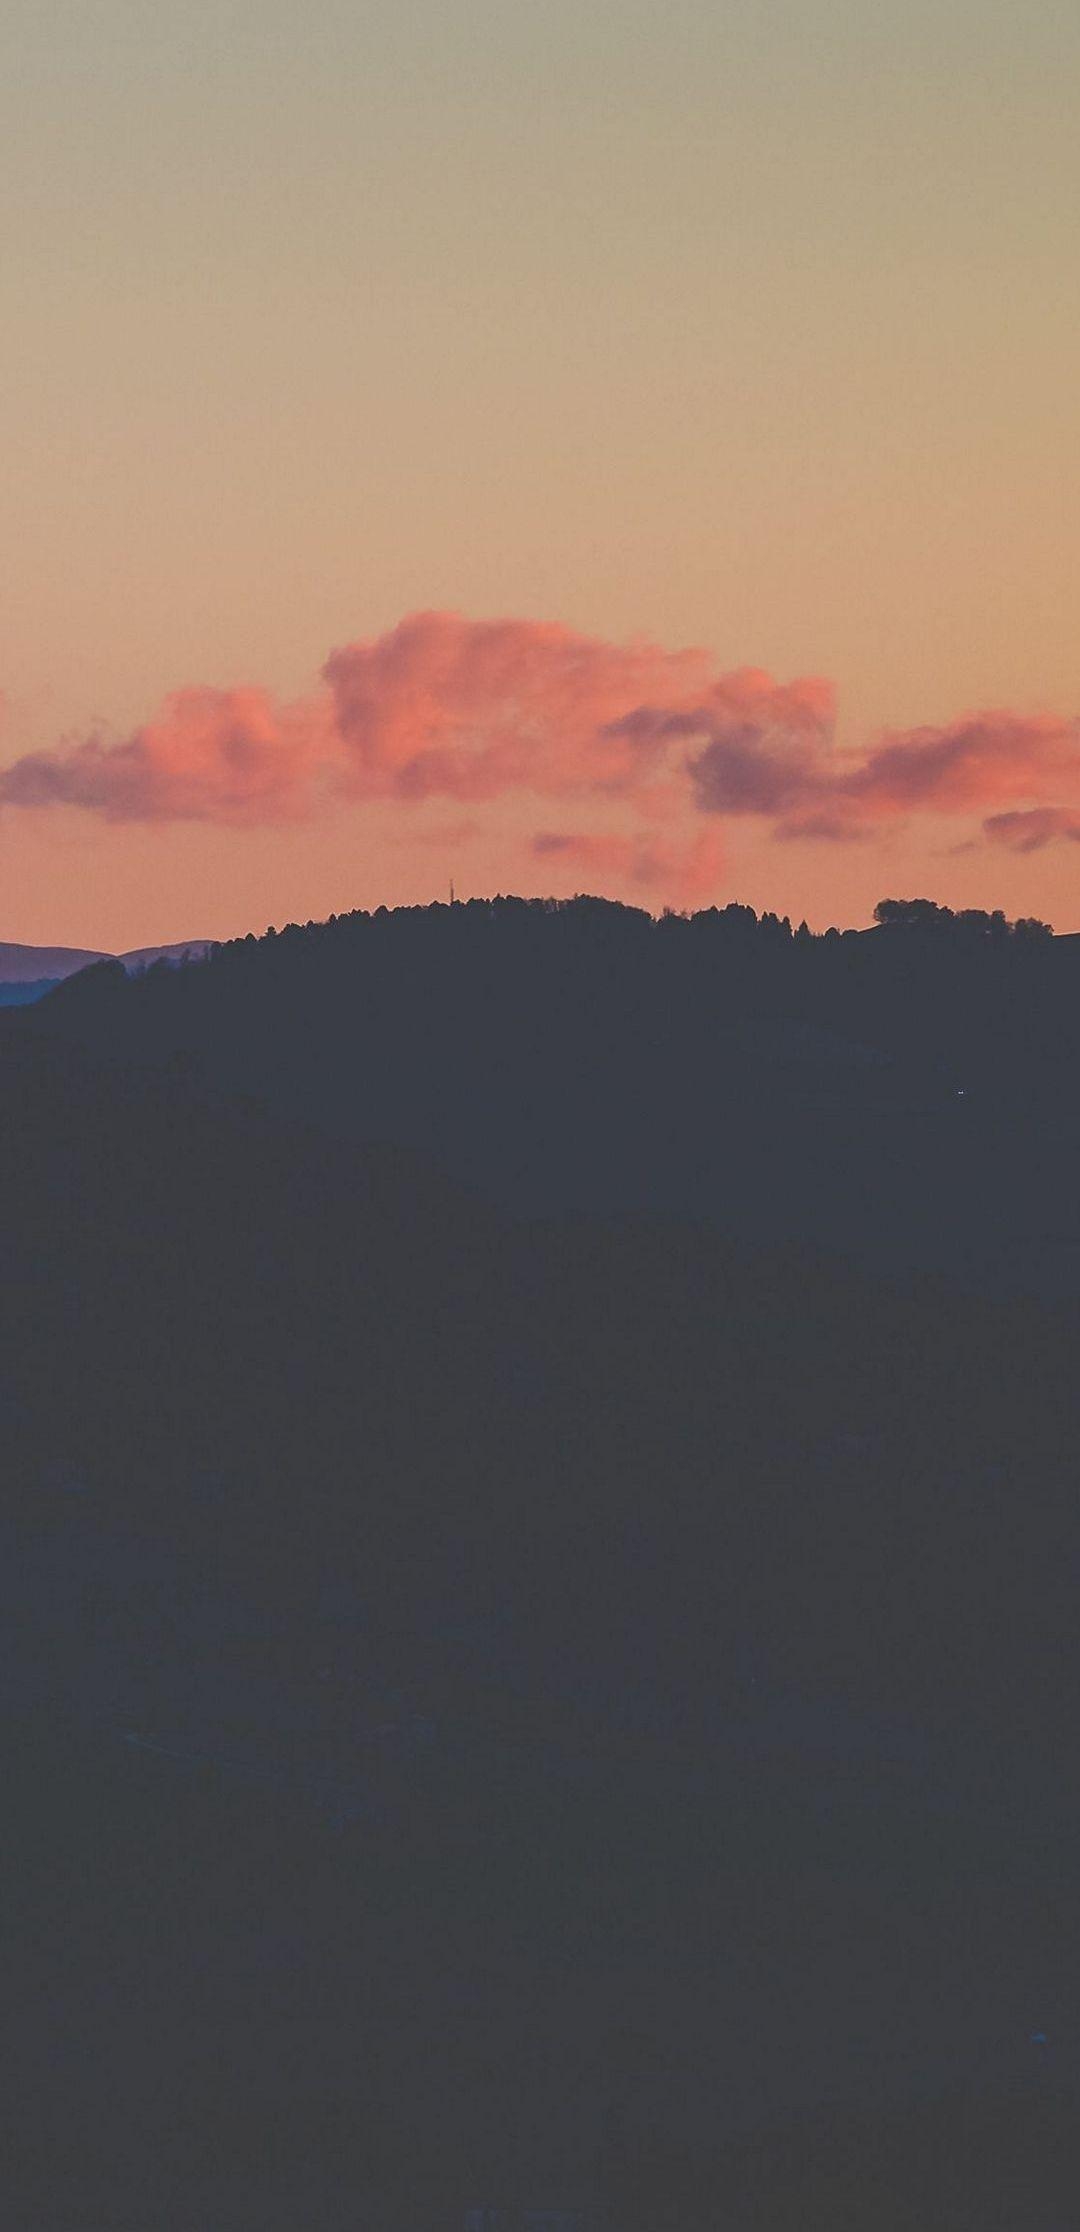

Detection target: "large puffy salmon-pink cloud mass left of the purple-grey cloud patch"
[0, 612, 830, 839]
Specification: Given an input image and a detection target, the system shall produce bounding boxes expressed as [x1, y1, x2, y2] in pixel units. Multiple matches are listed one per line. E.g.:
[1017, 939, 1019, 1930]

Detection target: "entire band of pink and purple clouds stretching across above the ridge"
[0, 612, 1080, 893]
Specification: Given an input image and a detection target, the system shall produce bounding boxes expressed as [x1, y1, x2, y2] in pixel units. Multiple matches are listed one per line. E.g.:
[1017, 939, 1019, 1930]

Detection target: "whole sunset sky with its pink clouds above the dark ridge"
[0, 0, 1080, 949]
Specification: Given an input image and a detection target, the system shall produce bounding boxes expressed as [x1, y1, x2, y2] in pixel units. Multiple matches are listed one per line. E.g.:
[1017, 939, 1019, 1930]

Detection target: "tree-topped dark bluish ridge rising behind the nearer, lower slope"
[31, 899, 1080, 1292]
